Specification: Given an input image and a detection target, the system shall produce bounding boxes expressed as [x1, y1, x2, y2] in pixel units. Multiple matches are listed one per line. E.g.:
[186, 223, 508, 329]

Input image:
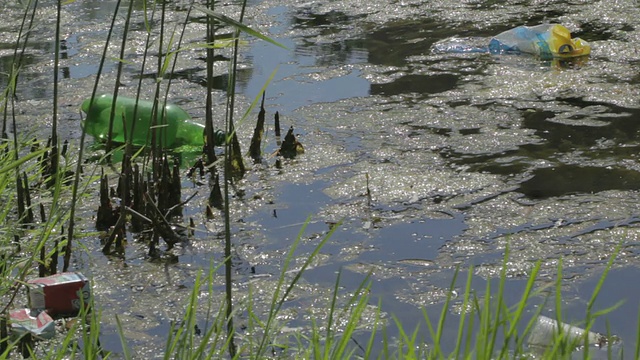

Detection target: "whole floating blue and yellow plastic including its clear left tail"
[434, 24, 591, 60]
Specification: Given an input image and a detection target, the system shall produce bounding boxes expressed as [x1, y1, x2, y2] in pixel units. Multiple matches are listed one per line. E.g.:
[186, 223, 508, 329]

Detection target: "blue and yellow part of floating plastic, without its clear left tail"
[489, 24, 591, 60]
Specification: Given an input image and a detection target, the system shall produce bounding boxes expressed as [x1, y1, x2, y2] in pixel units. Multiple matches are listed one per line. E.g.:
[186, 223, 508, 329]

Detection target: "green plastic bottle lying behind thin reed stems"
[82, 94, 225, 147]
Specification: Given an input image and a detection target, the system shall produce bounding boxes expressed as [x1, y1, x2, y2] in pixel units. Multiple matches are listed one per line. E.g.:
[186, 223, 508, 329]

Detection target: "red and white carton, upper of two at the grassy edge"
[27, 272, 91, 317]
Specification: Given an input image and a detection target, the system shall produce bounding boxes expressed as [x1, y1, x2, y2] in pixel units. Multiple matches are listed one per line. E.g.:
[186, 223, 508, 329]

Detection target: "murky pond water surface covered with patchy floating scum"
[0, 0, 640, 357]
